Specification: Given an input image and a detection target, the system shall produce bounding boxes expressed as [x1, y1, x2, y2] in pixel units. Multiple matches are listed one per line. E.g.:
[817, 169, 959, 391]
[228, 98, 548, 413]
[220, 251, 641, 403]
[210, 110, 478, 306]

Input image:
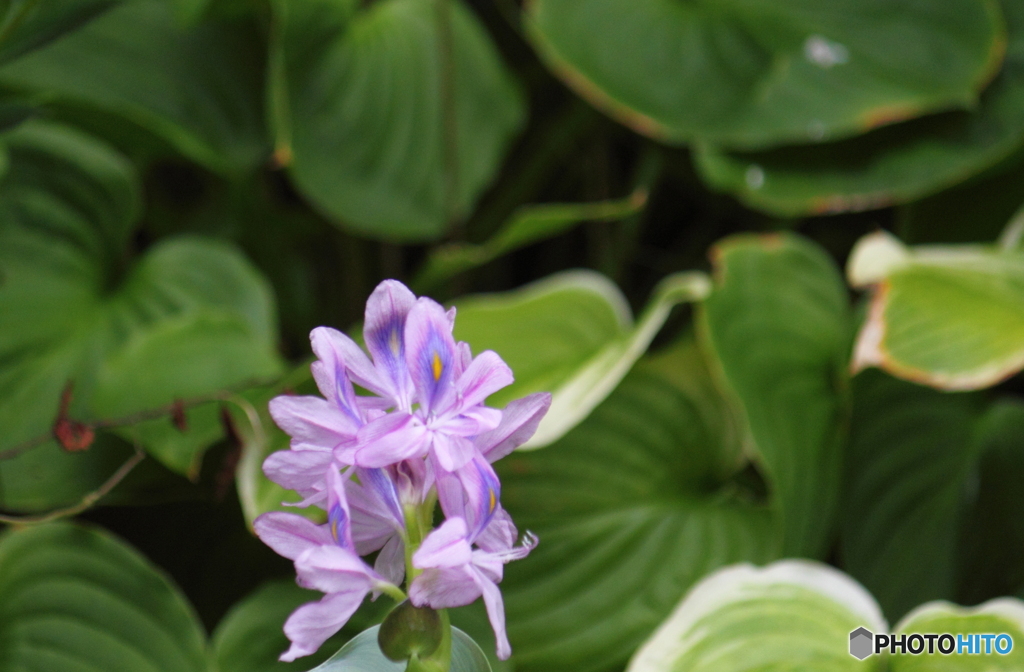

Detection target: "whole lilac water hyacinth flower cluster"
[255, 280, 551, 661]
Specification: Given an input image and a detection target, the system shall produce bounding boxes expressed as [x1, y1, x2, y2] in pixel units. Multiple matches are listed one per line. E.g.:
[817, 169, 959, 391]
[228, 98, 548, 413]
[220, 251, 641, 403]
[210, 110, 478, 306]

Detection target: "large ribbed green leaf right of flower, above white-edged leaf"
[498, 360, 780, 672]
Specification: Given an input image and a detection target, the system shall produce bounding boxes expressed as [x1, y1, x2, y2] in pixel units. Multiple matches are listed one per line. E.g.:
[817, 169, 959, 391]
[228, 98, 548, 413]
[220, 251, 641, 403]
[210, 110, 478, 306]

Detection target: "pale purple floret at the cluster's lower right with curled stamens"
[409, 514, 537, 661]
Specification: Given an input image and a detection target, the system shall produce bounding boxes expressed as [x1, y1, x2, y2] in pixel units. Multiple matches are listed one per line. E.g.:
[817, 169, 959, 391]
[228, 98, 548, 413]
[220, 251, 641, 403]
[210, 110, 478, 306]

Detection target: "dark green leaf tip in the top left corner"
[0, 0, 120, 62]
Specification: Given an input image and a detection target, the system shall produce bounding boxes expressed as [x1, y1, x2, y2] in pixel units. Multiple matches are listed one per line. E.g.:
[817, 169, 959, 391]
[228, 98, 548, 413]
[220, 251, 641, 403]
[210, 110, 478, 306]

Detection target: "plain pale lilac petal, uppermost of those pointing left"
[269, 395, 359, 451]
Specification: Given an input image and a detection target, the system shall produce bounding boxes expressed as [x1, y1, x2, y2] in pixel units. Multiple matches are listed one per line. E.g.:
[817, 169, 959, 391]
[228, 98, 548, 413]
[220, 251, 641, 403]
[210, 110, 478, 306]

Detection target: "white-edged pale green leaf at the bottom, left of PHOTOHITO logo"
[627, 560, 887, 672]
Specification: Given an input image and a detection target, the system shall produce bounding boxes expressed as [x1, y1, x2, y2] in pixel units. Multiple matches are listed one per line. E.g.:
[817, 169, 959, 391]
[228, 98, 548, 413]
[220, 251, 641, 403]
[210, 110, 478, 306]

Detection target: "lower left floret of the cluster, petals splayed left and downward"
[255, 468, 400, 662]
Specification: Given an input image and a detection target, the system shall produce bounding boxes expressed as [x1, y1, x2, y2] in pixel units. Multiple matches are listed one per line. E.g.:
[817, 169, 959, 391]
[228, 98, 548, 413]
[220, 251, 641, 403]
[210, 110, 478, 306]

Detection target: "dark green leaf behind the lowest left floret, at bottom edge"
[211, 580, 391, 672]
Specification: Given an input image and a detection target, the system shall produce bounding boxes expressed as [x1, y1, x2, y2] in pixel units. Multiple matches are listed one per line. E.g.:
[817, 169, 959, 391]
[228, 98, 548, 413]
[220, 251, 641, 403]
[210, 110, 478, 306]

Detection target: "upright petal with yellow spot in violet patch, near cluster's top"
[406, 298, 457, 415]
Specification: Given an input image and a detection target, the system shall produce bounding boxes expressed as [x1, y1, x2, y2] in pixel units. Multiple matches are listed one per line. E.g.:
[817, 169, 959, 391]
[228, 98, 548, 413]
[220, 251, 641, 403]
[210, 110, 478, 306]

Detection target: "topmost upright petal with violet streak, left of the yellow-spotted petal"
[362, 280, 416, 411]
